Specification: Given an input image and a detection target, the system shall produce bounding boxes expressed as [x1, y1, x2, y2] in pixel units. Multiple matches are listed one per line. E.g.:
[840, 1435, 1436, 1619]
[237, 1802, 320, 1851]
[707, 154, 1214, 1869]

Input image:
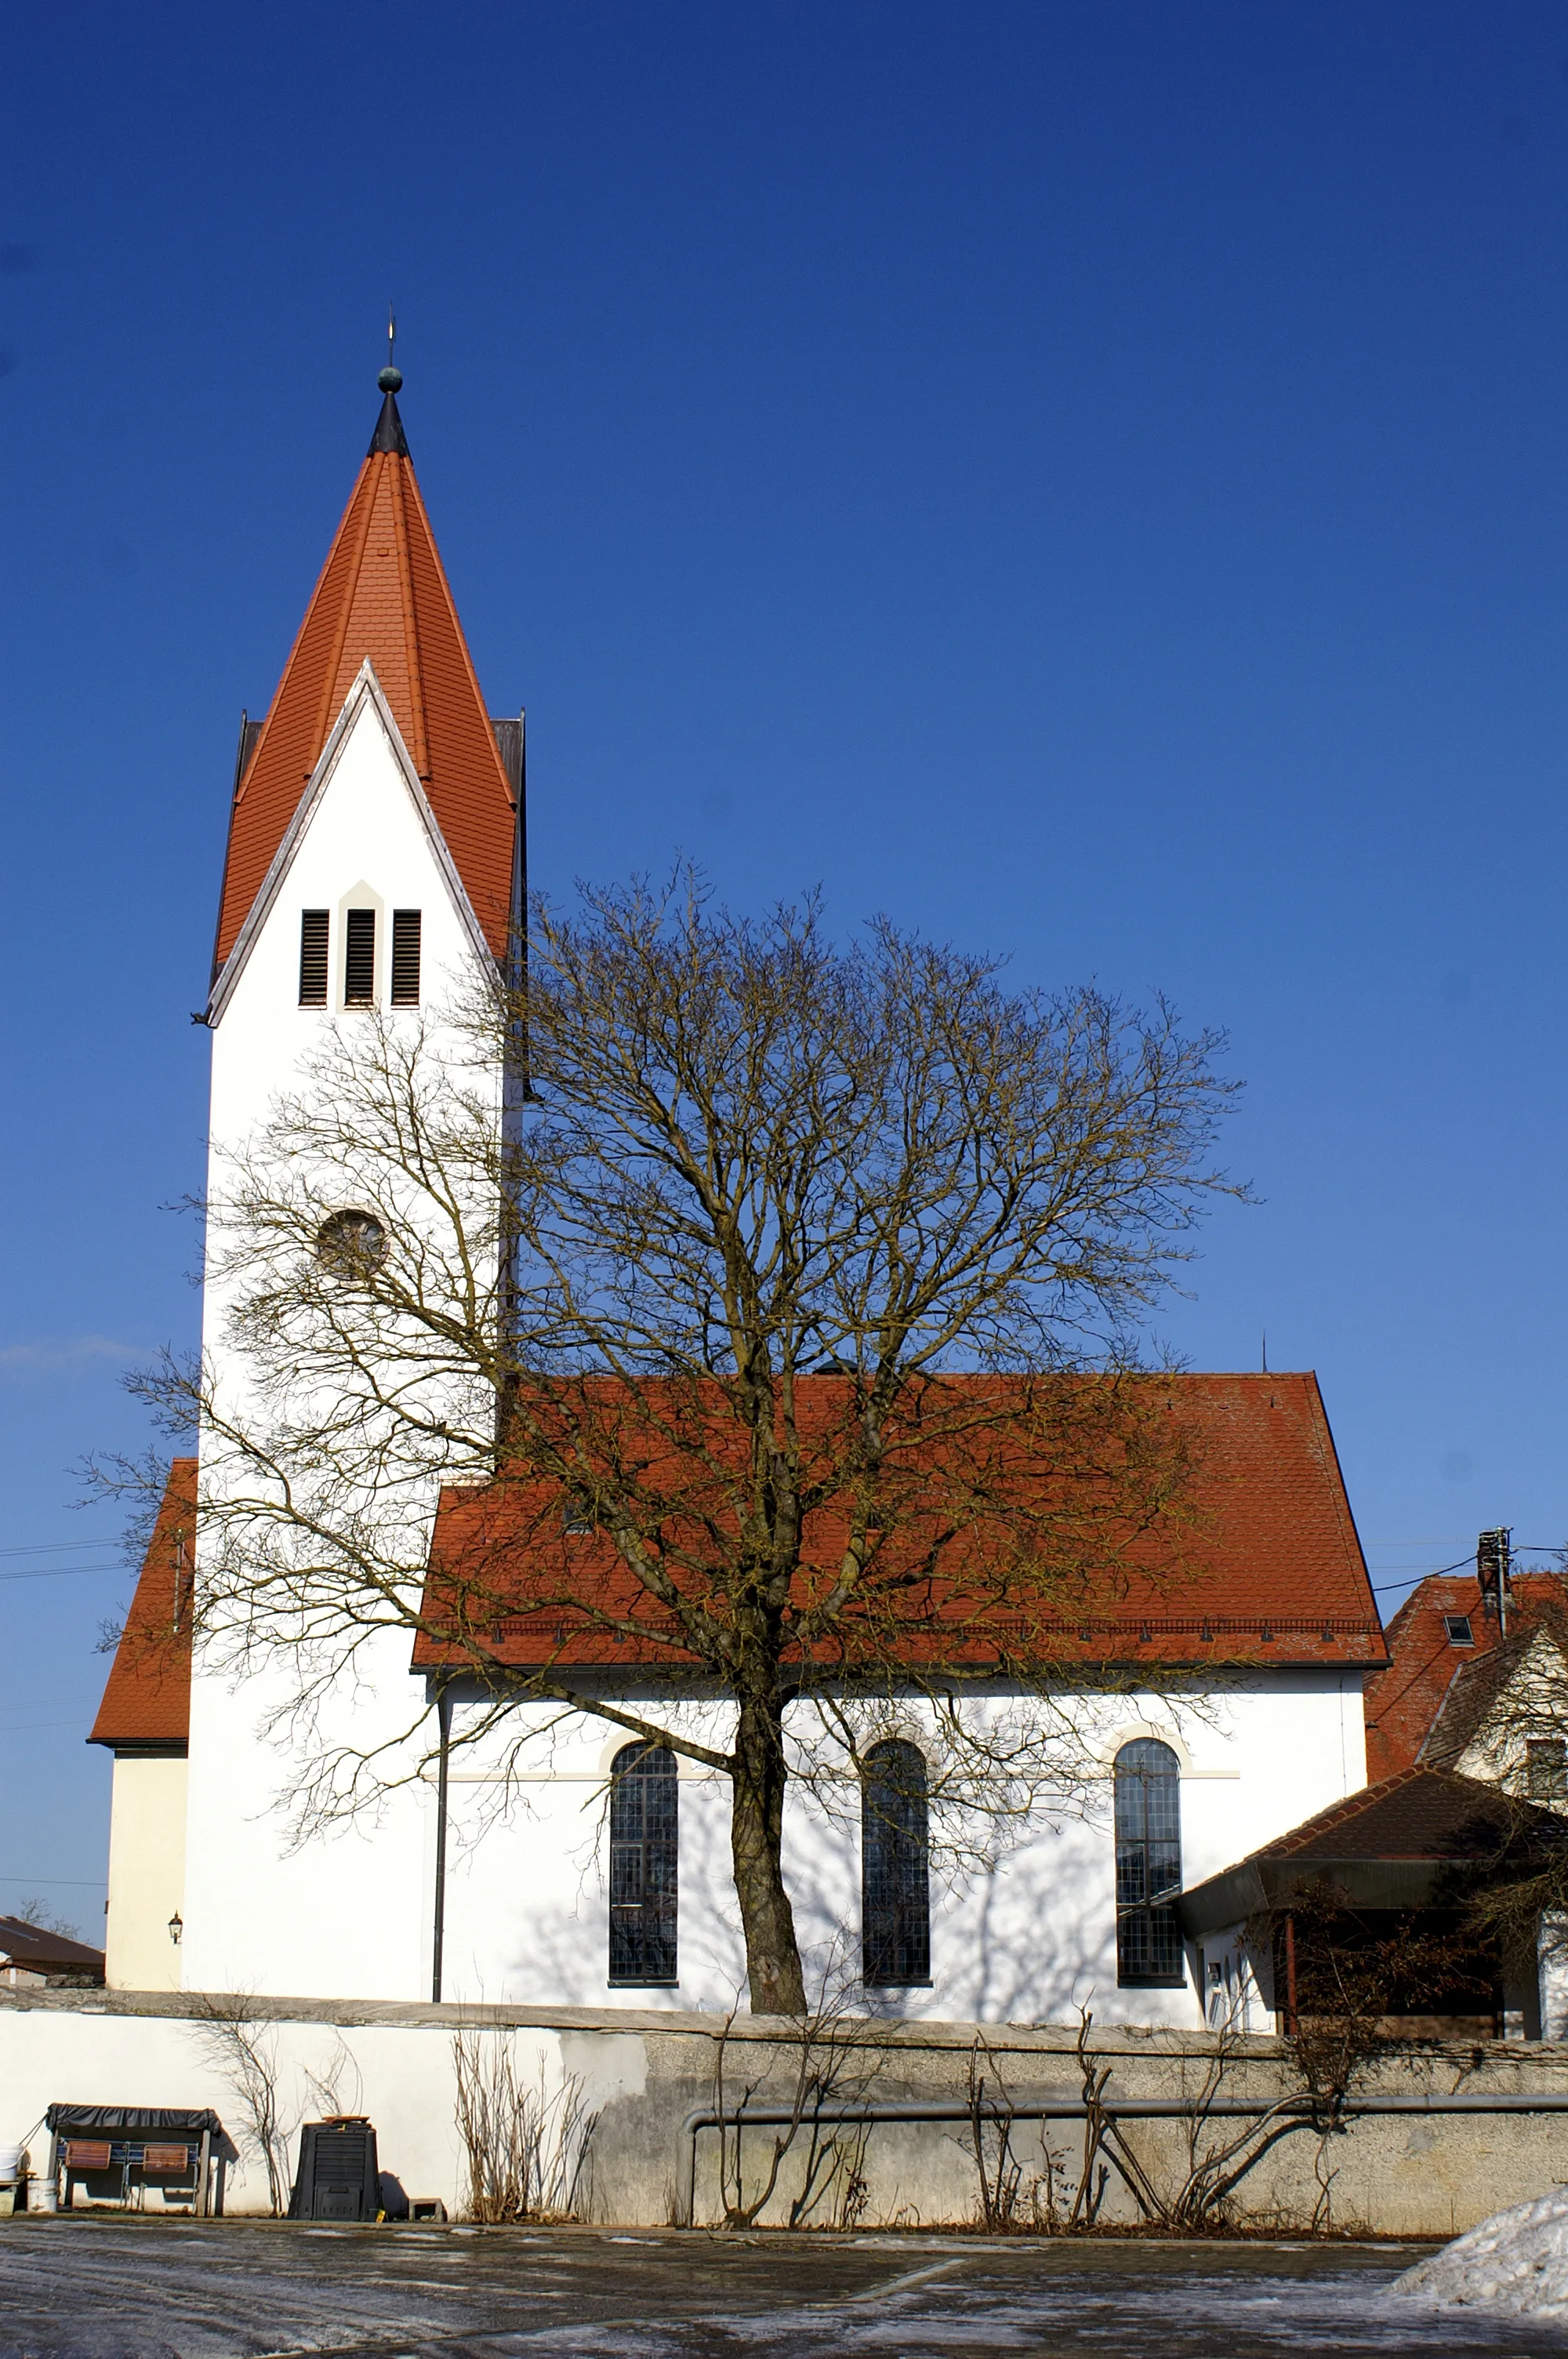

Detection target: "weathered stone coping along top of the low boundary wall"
[0, 1986, 1568, 2088]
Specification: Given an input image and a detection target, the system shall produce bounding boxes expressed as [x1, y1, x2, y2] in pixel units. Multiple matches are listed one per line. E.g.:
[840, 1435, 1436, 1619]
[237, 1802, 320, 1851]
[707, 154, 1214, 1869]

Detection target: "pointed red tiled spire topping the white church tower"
[212, 368, 517, 974]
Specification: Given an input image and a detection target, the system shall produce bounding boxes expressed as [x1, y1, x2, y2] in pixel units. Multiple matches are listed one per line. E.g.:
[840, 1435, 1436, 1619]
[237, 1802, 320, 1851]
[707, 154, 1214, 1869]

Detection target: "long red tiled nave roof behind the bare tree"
[412, 1376, 1386, 1670]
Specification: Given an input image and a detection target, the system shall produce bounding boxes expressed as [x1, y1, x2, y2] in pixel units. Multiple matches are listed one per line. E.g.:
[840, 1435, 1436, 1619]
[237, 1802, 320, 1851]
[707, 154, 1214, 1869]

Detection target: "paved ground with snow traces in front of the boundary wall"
[0, 2215, 1563, 2359]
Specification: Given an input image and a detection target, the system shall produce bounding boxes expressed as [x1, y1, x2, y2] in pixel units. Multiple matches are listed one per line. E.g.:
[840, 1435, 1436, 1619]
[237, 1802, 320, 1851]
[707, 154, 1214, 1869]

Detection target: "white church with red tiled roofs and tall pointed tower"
[89, 368, 1388, 2029]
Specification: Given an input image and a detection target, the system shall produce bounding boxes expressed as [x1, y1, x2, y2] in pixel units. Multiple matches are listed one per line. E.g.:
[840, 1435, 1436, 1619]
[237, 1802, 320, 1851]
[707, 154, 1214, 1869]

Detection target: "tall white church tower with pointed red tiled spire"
[182, 365, 524, 1998]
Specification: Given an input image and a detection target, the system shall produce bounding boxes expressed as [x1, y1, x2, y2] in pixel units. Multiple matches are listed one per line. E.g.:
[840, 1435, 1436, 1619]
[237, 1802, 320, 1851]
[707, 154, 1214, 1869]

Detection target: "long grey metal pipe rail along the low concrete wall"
[674, 2090, 1568, 2227]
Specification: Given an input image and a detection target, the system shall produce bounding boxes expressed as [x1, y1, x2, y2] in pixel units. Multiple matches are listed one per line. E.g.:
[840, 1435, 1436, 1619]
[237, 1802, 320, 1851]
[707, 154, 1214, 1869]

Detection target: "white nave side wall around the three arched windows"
[424, 1670, 1365, 2026]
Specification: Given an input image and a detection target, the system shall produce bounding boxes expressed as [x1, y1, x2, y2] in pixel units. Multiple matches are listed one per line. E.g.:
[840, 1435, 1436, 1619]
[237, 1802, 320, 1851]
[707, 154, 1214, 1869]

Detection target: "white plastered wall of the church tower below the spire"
[182, 682, 500, 1998]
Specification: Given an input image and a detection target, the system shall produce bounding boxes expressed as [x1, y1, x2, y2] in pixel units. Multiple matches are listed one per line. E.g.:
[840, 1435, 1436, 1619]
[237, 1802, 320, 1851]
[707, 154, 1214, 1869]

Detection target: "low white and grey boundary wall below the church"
[12, 1991, 1568, 2237]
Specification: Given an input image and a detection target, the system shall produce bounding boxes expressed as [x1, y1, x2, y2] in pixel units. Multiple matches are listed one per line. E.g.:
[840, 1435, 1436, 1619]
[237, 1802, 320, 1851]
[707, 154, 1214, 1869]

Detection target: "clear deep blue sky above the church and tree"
[0, 0, 1568, 1930]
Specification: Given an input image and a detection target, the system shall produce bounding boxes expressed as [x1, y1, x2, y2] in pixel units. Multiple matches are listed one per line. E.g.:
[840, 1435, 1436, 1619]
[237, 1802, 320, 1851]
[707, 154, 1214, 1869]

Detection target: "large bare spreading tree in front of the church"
[106, 878, 1238, 2017]
